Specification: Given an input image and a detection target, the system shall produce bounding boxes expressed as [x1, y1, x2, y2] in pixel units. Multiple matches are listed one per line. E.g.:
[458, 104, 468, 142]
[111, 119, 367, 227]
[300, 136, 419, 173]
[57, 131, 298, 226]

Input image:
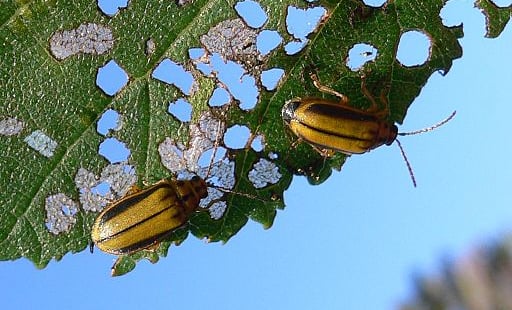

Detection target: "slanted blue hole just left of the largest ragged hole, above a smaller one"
[151, 58, 194, 95]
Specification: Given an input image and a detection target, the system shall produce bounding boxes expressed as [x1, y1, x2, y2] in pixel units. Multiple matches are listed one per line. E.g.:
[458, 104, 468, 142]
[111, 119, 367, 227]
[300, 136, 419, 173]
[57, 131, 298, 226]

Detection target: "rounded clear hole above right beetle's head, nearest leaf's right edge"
[396, 30, 431, 67]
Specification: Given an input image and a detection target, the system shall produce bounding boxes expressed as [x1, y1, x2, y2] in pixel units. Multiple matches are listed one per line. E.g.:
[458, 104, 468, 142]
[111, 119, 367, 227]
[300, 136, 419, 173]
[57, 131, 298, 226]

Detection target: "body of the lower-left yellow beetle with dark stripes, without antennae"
[91, 176, 208, 255]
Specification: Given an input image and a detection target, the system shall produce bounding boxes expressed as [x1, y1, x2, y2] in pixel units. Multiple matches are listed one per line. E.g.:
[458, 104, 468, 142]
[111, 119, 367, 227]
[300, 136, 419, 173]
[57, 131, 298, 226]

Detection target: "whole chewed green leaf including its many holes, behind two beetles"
[0, 0, 472, 274]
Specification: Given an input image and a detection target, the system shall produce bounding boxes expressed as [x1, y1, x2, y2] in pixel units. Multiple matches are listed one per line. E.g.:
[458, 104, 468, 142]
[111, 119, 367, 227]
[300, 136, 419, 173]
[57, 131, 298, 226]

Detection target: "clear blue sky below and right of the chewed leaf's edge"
[0, 1, 512, 310]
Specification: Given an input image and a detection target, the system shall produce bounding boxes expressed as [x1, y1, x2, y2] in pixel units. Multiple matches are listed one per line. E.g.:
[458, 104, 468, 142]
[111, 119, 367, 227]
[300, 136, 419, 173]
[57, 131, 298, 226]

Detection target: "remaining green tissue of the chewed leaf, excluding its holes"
[0, 0, 462, 275]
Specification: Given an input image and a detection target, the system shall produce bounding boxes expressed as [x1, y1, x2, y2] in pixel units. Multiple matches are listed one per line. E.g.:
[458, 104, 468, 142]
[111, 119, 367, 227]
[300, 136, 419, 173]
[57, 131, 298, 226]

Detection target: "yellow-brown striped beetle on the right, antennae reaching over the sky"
[281, 74, 456, 187]
